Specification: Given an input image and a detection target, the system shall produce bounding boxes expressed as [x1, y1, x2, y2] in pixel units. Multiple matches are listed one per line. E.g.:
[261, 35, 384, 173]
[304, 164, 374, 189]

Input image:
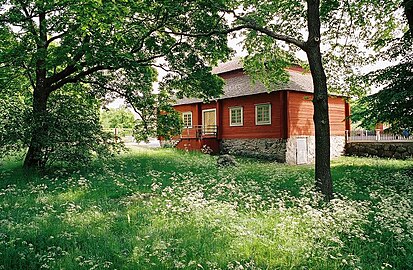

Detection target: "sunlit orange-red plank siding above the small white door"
[288, 91, 346, 137]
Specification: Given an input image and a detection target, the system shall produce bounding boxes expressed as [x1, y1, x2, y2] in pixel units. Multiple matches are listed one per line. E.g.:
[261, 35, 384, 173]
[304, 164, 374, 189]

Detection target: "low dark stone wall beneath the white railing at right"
[346, 142, 413, 159]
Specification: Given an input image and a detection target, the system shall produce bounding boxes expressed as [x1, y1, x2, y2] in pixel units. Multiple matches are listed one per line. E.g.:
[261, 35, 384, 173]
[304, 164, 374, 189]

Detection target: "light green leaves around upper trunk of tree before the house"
[230, 0, 405, 96]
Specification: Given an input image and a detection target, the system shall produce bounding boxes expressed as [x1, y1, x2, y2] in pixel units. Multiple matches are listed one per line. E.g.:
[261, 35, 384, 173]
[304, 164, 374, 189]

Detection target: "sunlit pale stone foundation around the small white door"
[285, 136, 346, 164]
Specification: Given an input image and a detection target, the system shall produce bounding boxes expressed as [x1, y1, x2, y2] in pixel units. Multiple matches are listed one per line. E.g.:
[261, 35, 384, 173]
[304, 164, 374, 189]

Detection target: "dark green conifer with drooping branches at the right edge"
[352, 0, 413, 132]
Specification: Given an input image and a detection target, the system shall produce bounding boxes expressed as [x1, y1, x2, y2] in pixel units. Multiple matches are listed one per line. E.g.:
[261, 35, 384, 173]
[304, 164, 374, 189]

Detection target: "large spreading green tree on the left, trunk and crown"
[0, 0, 230, 167]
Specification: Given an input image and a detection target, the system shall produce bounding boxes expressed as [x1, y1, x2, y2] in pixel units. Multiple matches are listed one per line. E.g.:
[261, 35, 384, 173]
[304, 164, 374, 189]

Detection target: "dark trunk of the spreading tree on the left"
[23, 87, 49, 168]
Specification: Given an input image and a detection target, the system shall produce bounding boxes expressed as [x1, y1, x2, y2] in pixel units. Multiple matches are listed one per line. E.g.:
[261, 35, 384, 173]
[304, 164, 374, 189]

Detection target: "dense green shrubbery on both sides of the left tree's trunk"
[0, 81, 122, 166]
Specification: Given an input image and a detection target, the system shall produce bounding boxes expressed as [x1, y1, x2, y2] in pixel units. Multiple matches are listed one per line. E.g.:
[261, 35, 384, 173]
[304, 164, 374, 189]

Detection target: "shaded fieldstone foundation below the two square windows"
[221, 139, 286, 162]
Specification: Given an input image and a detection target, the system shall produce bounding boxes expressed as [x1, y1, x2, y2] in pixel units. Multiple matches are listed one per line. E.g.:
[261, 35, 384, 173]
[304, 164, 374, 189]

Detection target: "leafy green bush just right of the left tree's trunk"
[42, 86, 121, 166]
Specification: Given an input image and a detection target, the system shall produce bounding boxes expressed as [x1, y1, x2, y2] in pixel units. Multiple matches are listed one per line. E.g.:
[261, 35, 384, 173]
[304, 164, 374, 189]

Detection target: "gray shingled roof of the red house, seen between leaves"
[175, 59, 314, 105]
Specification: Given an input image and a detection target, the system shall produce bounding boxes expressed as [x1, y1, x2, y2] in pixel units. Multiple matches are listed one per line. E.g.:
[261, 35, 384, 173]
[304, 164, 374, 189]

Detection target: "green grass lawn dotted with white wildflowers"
[0, 149, 413, 269]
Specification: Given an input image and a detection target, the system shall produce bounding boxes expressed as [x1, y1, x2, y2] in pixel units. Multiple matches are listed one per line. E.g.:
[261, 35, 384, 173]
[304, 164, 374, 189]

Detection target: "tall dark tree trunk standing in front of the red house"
[307, 0, 333, 198]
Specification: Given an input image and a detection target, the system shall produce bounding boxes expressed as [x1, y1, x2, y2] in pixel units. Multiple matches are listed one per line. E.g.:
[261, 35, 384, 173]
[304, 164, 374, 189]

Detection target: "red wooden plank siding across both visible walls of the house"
[174, 91, 349, 139]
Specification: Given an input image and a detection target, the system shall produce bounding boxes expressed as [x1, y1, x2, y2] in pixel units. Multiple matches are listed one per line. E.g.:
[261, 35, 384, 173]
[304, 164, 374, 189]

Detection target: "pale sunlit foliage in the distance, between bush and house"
[100, 106, 135, 128]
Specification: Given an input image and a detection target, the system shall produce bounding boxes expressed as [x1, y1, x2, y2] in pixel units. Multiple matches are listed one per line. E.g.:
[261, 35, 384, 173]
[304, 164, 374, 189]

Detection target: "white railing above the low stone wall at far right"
[346, 129, 413, 142]
